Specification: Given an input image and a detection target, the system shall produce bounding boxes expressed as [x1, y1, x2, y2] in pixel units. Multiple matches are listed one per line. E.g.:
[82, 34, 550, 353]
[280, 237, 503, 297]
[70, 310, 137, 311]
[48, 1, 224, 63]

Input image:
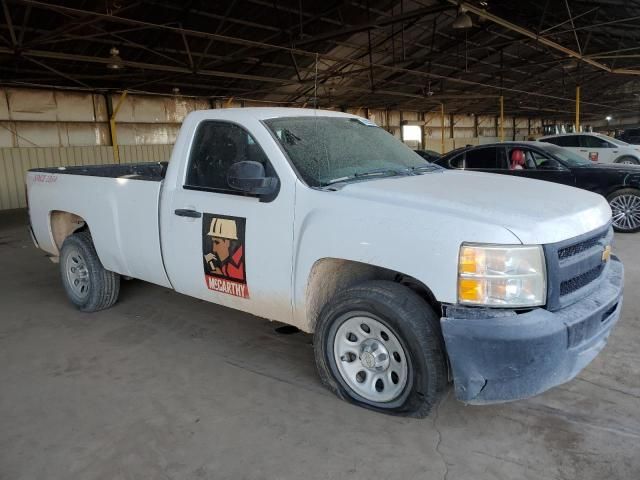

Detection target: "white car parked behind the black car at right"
[538, 133, 640, 165]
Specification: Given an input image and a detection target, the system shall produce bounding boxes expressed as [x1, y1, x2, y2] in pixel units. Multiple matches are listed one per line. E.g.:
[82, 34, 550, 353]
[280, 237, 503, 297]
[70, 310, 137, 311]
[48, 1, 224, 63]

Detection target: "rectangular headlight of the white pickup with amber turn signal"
[458, 243, 547, 308]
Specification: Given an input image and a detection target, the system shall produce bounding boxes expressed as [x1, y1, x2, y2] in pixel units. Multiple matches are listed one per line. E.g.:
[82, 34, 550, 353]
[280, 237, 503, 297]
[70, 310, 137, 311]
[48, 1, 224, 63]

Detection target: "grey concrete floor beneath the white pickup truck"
[0, 212, 640, 480]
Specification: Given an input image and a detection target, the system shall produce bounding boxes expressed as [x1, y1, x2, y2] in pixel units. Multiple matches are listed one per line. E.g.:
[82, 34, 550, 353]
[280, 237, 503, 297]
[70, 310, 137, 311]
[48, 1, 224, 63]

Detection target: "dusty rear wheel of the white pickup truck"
[60, 230, 120, 312]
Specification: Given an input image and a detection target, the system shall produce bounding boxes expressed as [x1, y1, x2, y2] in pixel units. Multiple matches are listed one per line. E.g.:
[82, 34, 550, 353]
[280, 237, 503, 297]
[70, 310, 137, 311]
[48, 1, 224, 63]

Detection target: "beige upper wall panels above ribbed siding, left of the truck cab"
[0, 88, 211, 147]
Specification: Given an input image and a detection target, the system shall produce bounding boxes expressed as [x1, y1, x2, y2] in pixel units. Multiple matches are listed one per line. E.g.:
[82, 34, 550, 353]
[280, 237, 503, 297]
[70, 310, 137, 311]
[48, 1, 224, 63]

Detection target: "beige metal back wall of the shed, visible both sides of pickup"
[0, 88, 542, 210]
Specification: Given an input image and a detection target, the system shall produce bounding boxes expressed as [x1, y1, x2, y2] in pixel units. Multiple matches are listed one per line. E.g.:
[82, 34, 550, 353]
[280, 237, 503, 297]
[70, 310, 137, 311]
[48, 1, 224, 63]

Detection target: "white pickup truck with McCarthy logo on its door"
[27, 108, 623, 417]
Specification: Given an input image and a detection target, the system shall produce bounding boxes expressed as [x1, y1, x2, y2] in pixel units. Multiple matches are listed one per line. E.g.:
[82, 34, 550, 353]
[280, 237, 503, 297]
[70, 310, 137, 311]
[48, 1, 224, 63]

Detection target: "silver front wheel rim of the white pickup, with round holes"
[333, 316, 409, 403]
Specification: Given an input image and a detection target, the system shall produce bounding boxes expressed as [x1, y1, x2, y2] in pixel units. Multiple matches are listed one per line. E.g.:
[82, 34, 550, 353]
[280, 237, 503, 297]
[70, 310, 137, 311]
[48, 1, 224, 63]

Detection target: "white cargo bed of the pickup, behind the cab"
[26, 163, 170, 287]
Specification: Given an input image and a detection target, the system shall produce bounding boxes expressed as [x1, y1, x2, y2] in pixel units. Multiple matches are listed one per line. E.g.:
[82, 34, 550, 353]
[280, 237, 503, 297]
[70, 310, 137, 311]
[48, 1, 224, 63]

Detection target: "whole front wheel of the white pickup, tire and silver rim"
[314, 281, 447, 418]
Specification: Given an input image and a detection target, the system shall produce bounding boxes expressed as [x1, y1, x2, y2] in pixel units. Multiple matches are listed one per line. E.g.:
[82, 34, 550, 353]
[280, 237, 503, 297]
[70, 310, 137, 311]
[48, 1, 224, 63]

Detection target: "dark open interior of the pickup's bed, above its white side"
[29, 162, 169, 182]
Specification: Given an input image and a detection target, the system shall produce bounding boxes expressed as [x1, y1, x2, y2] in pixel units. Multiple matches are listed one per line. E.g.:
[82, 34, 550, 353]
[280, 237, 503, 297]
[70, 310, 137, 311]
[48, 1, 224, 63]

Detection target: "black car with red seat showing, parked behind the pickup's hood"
[434, 142, 640, 233]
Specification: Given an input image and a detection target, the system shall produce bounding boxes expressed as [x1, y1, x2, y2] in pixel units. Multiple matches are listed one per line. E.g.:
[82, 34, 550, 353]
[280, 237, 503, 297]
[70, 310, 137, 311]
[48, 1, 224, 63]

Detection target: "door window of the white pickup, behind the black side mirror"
[185, 121, 270, 195]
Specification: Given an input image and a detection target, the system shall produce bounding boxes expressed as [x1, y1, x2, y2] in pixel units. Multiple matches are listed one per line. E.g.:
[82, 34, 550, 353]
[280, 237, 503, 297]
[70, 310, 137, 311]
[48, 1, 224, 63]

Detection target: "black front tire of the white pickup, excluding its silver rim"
[314, 281, 447, 418]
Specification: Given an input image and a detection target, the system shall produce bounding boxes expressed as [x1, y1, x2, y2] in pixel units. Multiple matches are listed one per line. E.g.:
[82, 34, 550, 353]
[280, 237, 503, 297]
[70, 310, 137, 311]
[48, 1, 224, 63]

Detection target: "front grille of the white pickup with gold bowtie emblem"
[544, 225, 613, 311]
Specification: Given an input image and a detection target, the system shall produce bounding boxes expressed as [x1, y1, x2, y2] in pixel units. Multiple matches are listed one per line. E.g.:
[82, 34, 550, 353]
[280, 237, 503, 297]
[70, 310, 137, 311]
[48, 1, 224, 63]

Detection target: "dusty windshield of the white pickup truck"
[265, 116, 441, 187]
